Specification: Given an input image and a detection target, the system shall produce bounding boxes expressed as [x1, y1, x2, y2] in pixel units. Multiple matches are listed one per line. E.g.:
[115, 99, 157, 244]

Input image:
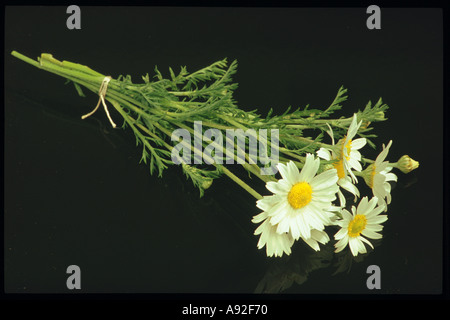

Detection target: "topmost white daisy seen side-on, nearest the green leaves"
[317, 114, 366, 206]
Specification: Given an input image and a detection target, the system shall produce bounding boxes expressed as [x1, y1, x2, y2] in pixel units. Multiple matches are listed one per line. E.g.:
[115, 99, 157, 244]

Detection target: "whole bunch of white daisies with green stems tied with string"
[11, 51, 419, 257]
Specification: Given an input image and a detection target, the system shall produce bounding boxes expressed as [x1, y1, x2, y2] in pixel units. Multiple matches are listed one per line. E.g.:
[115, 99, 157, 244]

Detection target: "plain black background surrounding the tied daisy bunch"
[4, 6, 443, 295]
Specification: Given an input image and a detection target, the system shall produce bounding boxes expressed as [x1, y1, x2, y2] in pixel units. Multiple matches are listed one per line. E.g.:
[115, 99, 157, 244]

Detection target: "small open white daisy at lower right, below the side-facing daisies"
[334, 197, 387, 256]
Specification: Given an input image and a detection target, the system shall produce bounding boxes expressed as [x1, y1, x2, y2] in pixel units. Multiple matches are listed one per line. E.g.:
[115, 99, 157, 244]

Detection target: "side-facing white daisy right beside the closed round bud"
[363, 140, 397, 211]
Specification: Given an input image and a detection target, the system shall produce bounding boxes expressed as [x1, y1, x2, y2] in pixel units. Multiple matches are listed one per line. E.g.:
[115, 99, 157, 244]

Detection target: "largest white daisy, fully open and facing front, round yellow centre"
[259, 154, 339, 240]
